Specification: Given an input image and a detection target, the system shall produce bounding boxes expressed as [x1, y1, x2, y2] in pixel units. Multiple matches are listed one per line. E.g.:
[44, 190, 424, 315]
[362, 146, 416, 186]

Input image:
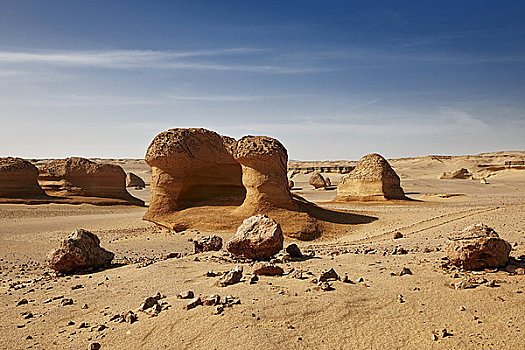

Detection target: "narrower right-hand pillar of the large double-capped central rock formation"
[234, 136, 297, 214]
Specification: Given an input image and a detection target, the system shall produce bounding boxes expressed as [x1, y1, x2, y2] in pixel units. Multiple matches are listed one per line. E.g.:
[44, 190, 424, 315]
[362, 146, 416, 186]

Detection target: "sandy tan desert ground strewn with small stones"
[0, 152, 525, 349]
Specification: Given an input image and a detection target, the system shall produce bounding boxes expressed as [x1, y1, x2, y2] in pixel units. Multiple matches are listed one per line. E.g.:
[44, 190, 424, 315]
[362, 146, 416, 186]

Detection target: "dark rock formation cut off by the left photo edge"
[0, 157, 45, 198]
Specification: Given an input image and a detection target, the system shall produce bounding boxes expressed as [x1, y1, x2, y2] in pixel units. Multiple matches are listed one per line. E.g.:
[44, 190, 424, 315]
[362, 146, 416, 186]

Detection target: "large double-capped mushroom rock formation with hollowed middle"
[144, 128, 370, 240]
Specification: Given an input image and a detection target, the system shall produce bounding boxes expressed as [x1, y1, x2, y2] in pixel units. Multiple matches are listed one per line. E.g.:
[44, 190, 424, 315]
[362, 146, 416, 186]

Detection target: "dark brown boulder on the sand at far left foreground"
[48, 229, 114, 273]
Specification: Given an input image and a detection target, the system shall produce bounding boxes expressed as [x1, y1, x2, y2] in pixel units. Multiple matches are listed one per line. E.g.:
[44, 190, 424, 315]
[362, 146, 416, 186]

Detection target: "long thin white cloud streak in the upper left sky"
[0, 48, 327, 74]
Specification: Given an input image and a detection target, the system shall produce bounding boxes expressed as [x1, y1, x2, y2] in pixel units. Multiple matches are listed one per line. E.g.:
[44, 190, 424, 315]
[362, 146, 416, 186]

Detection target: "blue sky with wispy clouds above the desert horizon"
[0, 0, 525, 160]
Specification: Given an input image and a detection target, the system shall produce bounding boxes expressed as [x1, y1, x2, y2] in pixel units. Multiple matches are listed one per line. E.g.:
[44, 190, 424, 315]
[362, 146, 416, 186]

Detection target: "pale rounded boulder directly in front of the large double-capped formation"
[226, 215, 284, 260]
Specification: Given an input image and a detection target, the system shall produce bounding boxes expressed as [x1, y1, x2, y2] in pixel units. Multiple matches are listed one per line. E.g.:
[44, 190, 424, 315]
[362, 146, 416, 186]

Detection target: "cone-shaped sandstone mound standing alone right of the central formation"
[335, 153, 406, 201]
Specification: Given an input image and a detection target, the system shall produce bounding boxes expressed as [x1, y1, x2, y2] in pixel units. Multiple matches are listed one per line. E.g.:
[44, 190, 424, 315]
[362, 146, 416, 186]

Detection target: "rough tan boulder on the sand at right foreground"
[446, 224, 511, 270]
